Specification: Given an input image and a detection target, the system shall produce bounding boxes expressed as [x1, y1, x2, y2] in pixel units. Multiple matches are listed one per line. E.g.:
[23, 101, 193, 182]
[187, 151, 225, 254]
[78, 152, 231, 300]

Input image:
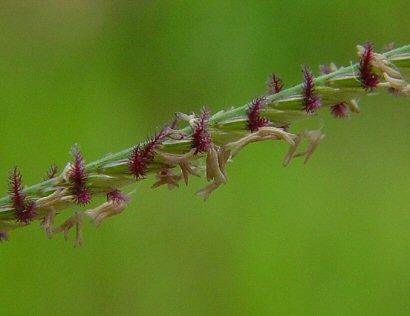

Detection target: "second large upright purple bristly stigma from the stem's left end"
[69, 145, 91, 205]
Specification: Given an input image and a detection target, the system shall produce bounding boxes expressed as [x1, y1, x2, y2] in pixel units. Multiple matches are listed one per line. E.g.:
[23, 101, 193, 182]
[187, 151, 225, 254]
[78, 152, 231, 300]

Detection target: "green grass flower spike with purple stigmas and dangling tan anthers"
[0, 44, 410, 244]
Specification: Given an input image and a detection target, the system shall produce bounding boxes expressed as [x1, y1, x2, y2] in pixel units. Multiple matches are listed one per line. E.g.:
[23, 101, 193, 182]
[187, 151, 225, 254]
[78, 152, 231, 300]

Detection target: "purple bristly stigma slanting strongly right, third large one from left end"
[128, 128, 167, 179]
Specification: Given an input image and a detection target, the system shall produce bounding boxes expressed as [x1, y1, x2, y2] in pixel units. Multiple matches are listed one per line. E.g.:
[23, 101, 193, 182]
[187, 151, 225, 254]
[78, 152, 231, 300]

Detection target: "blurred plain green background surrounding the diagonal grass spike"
[0, 0, 410, 315]
